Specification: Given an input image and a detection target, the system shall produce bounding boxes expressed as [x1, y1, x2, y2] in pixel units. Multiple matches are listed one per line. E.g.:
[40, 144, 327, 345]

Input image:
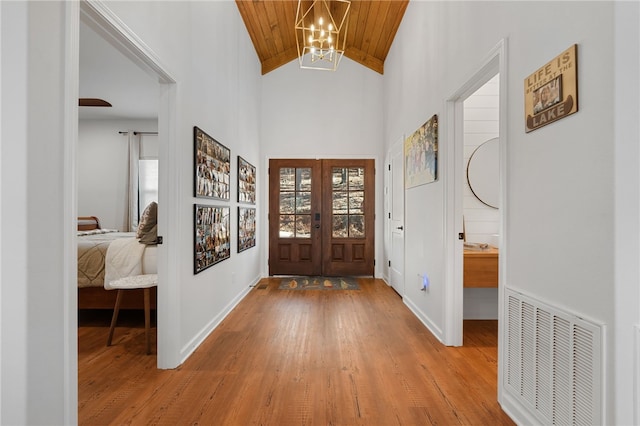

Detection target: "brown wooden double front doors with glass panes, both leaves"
[269, 159, 375, 276]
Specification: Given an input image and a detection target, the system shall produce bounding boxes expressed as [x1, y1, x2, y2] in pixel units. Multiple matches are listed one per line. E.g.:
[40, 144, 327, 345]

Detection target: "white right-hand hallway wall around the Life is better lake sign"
[384, 2, 638, 424]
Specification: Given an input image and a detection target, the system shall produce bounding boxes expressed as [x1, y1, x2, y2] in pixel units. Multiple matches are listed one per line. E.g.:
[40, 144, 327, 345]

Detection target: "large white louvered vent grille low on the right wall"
[504, 289, 603, 425]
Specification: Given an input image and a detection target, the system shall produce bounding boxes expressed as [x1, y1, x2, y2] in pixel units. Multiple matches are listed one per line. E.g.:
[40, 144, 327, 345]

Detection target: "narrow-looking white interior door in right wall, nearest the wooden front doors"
[389, 140, 404, 296]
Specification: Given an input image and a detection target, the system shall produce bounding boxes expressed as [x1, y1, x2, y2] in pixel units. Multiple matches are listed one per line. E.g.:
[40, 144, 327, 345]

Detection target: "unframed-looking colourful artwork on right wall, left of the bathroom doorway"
[404, 115, 438, 189]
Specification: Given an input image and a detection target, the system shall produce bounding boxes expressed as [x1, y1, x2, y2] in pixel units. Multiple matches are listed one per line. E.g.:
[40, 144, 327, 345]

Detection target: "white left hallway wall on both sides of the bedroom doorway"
[0, 2, 265, 425]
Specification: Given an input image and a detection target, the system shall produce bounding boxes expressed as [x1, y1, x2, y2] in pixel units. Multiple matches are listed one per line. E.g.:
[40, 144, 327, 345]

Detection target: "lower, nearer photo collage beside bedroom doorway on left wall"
[193, 204, 231, 274]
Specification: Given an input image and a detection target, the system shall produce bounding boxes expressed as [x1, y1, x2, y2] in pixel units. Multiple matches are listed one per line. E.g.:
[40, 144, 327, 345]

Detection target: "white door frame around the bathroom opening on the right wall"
[443, 39, 509, 392]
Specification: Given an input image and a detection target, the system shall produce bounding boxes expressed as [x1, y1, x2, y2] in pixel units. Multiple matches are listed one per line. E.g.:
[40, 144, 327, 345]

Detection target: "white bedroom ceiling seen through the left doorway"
[78, 20, 160, 120]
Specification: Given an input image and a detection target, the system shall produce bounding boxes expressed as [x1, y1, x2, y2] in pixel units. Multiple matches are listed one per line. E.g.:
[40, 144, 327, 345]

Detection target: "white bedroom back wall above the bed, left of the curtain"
[78, 120, 158, 231]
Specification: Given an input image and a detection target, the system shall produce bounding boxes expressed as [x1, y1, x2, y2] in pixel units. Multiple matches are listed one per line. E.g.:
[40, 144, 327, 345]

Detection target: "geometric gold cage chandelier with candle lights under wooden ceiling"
[296, 0, 351, 71]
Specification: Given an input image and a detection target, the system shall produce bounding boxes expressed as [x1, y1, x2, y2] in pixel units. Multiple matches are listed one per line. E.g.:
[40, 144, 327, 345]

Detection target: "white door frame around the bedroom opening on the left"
[70, 0, 181, 380]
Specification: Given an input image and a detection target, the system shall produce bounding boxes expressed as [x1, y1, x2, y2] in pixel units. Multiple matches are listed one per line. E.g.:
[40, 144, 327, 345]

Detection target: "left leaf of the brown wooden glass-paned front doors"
[269, 160, 322, 275]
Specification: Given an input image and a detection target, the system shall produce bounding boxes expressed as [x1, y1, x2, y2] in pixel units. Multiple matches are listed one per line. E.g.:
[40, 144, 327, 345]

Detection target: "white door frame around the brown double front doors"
[258, 154, 385, 278]
